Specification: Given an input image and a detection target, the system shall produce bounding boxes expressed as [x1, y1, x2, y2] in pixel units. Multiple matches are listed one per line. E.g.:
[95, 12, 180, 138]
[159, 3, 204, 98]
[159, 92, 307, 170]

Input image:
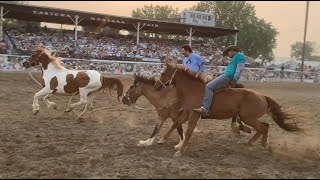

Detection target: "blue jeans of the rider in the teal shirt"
[202, 74, 230, 111]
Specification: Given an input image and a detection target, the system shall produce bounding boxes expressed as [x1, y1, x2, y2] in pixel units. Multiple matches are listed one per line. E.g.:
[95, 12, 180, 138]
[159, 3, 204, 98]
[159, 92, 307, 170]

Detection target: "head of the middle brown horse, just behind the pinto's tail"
[122, 74, 142, 106]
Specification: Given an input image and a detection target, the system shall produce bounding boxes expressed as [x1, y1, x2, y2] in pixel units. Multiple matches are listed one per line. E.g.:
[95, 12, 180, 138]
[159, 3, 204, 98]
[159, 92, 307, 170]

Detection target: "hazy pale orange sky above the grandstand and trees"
[29, 1, 320, 58]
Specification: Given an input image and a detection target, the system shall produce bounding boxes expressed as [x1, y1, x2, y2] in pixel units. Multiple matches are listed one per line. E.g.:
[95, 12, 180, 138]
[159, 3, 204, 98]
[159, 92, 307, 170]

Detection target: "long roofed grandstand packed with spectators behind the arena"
[0, 2, 318, 81]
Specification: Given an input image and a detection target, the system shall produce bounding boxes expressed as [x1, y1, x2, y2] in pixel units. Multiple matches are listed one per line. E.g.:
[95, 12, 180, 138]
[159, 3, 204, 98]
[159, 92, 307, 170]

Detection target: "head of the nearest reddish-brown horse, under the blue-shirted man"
[154, 62, 178, 91]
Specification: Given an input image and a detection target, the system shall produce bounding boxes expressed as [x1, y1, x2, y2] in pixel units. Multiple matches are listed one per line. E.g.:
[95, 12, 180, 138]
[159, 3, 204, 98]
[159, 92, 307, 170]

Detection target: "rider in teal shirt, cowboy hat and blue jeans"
[194, 46, 246, 114]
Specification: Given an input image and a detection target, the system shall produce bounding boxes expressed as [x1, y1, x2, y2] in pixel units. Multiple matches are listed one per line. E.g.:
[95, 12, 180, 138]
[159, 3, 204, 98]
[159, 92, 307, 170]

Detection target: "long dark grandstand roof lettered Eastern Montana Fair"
[0, 1, 239, 38]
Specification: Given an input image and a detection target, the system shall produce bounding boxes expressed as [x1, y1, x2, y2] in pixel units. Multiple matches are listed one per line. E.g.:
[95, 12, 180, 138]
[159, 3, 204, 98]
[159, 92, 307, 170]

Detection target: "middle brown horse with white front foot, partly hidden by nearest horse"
[122, 74, 251, 148]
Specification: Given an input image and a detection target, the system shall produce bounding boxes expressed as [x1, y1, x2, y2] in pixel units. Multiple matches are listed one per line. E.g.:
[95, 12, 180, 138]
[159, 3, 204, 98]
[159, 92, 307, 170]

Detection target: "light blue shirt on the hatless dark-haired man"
[182, 53, 204, 73]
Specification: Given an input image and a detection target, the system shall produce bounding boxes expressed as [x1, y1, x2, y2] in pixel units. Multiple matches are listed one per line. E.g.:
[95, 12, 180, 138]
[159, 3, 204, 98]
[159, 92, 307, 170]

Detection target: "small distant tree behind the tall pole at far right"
[290, 41, 316, 60]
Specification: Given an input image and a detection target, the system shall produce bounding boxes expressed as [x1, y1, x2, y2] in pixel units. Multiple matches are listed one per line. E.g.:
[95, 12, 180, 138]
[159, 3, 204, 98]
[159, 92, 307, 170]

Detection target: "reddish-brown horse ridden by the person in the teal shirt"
[154, 63, 302, 156]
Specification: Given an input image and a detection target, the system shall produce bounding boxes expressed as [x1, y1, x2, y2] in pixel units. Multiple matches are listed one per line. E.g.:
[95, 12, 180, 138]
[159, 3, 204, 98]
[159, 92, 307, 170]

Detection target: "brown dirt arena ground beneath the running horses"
[0, 73, 320, 178]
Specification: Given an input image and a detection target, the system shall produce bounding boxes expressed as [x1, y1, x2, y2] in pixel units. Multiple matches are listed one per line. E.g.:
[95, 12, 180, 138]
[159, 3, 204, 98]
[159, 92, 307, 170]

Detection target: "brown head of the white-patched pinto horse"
[22, 48, 50, 69]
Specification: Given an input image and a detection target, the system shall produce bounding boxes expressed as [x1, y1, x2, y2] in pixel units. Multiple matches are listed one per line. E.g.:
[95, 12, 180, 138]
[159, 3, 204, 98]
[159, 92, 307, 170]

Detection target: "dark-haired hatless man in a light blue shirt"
[181, 45, 204, 77]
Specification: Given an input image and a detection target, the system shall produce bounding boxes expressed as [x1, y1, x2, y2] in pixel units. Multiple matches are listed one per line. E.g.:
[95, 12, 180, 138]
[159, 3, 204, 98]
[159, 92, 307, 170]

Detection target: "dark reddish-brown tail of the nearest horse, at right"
[264, 96, 302, 132]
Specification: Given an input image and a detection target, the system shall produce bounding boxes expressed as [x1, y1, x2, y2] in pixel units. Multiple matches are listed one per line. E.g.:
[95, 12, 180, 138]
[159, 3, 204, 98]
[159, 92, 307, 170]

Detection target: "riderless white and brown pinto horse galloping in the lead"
[23, 48, 123, 116]
